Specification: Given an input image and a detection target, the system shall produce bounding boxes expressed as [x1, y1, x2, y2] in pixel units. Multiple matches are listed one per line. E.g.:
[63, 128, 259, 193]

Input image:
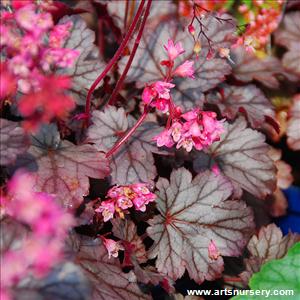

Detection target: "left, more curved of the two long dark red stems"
[85, 0, 146, 124]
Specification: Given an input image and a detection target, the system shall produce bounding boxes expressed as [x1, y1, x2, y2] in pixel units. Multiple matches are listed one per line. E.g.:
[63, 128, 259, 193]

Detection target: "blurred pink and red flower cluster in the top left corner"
[0, 1, 79, 129]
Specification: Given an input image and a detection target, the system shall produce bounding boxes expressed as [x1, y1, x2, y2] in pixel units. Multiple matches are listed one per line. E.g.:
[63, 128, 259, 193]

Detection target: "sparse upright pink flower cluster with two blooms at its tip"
[142, 39, 194, 113]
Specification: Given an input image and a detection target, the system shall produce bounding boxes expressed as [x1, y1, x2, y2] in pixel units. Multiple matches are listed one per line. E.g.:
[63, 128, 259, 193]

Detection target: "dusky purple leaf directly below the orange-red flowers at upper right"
[232, 47, 287, 89]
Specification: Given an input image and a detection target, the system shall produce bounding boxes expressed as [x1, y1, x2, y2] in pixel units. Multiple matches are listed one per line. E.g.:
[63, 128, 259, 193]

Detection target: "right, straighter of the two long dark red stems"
[107, 0, 152, 105]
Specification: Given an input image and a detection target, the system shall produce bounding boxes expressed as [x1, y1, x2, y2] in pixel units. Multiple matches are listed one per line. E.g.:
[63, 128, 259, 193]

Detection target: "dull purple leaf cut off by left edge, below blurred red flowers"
[0, 119, 29, 166]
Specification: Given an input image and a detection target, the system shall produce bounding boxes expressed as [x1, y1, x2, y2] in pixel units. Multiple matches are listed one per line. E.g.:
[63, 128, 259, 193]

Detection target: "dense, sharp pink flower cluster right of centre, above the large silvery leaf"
[153, 108, 224, 152]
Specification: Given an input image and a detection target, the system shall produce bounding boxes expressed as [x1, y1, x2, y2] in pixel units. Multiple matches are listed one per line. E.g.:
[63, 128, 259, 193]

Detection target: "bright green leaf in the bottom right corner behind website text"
[231, 242, 300, 300]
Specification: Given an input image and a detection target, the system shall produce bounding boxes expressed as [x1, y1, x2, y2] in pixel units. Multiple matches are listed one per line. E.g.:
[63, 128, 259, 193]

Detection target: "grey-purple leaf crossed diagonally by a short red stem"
[88, 106, 166, 184]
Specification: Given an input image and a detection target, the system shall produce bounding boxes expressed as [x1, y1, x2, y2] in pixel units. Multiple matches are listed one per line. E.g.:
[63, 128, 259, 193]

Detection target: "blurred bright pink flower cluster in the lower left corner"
[1, 171, 74, 299]
